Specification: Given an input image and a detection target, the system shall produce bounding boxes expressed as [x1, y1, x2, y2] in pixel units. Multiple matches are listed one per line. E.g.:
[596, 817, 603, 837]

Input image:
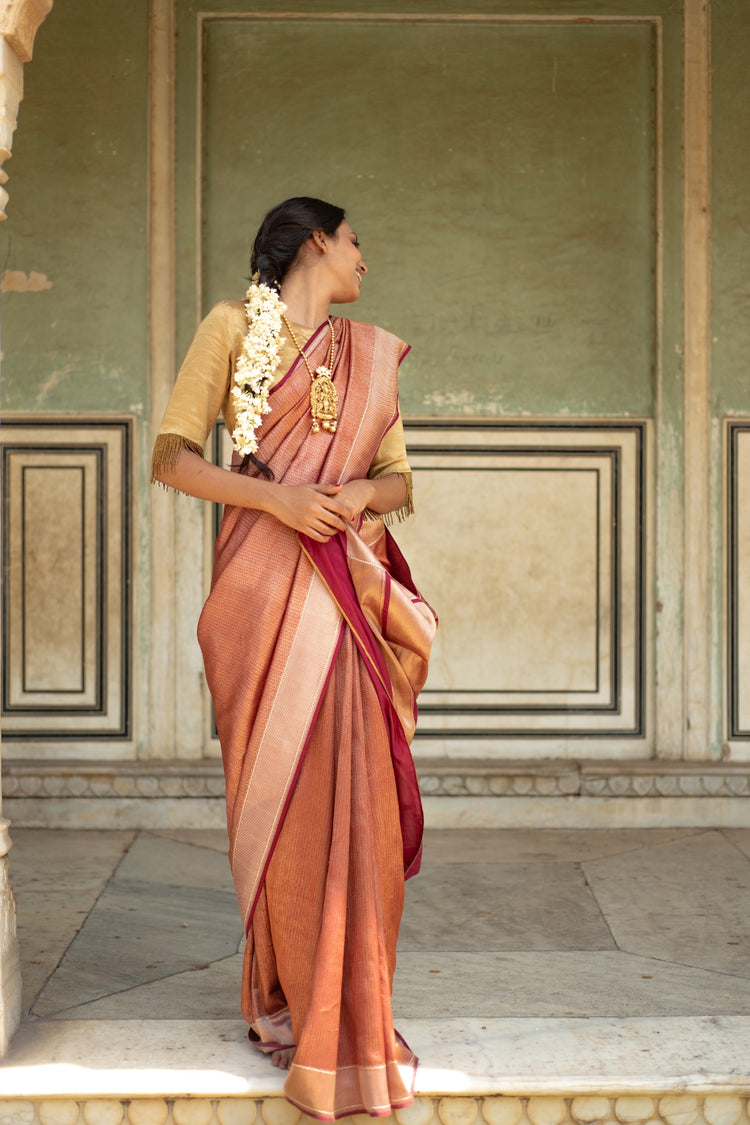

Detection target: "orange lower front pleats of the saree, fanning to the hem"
[243, 633, 416, 1121]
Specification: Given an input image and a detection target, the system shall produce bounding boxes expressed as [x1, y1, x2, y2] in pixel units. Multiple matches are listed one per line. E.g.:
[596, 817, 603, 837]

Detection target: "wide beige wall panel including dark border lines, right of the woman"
[395, 422, 649, 756]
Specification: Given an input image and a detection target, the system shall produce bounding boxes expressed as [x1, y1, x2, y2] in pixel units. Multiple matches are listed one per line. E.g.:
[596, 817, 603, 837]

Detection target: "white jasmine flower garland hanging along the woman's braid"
[232, 273, 287, 457]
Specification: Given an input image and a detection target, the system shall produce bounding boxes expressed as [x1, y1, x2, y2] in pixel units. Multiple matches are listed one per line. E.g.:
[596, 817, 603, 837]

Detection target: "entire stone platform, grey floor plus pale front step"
[0, 829, 750, 1125]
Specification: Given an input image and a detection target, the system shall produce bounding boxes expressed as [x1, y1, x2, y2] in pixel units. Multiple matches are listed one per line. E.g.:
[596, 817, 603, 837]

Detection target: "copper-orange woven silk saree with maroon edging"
[198, 320, 435, 1121]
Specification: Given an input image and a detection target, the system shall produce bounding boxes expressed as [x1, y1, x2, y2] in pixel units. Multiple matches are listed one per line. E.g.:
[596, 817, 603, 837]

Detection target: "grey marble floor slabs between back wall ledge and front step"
[0, 828, 750, 1089]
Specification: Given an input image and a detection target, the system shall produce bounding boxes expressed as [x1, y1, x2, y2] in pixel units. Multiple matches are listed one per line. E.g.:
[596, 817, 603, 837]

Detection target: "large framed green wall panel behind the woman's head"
[192, 17, 657, 415]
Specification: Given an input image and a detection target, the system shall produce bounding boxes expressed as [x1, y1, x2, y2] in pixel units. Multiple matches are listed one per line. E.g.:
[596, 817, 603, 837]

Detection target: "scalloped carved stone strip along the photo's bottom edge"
[0, 1090, 750, 1125]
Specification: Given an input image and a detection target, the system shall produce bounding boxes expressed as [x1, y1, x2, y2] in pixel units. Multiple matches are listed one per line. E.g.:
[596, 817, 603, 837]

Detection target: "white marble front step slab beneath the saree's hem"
[0, 1016, 750, 1098]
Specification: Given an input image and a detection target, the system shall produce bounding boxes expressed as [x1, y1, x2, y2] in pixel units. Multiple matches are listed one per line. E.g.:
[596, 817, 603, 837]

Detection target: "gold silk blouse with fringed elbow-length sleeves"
[152, 300, 412, 490]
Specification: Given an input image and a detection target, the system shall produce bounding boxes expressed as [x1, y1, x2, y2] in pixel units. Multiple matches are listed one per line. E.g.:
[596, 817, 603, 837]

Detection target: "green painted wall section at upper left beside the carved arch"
[0, 0, 148, 413]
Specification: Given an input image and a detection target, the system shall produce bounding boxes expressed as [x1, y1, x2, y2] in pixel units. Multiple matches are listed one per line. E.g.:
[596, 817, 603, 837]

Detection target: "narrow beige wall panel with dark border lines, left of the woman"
[2, 417, 132, 741]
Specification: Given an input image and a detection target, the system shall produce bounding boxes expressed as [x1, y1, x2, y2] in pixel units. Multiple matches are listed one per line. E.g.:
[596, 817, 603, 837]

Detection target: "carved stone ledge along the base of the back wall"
[2, 758, 750, 800]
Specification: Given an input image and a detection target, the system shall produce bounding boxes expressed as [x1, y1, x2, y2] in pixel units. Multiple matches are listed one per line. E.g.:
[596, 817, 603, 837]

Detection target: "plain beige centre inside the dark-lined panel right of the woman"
[416, 463, 608, 703]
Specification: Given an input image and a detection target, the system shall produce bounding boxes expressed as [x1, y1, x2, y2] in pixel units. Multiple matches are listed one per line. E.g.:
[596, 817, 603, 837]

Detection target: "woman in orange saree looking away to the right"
[153, 197, 435, 1121]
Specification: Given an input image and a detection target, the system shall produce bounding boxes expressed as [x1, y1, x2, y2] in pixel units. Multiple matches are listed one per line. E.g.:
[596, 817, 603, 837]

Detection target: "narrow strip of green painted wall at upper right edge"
[712, 0, 750, 417]
